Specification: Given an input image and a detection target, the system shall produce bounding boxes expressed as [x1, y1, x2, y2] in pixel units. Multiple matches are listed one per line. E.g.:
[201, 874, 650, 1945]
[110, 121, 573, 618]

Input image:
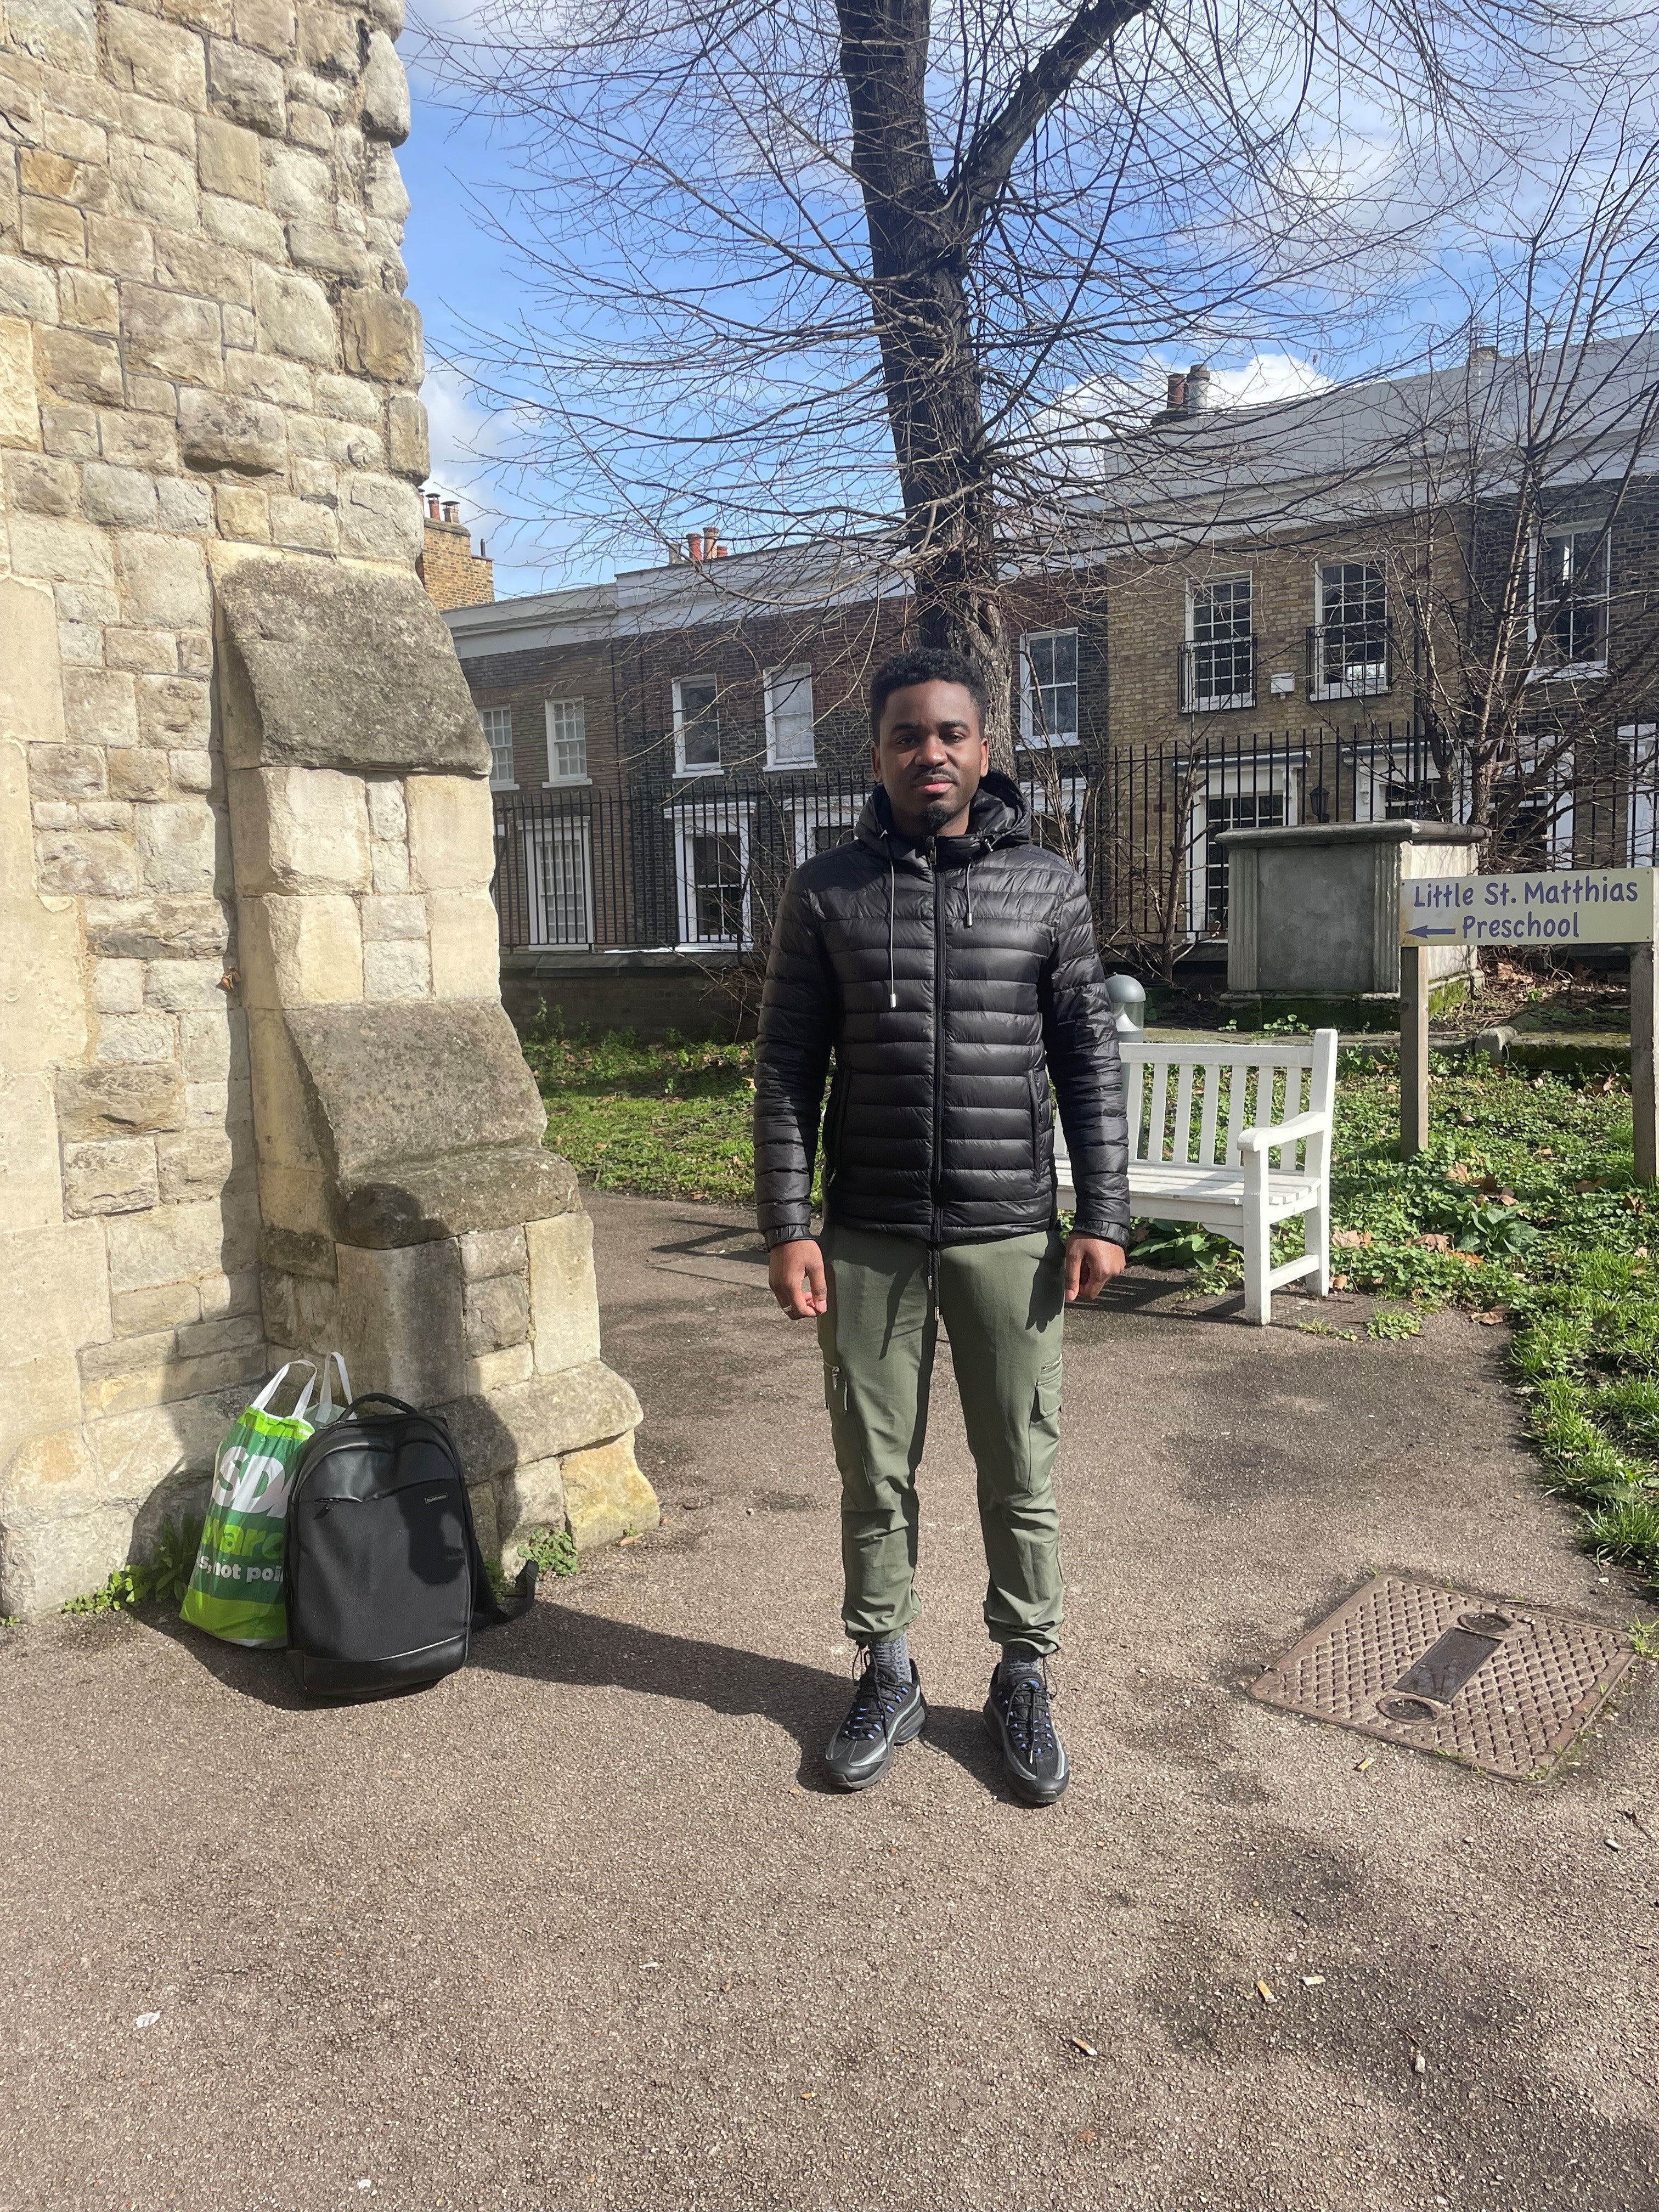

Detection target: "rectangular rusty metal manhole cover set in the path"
[1250, 1577, 1635, 1781]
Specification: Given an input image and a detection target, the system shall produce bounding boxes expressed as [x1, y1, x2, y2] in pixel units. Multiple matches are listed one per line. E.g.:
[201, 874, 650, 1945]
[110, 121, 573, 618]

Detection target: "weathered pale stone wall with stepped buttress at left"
[0, 0, 654, 1612]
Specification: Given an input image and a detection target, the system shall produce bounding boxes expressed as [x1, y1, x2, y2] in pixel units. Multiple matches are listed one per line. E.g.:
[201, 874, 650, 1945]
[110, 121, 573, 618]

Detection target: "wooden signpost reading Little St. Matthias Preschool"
[1400, 867, 1659, 1183]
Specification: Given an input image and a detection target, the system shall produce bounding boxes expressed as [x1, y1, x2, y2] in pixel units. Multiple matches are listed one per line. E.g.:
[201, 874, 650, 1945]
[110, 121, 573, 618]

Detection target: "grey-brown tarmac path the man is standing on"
[0, 1197, 1659, 2212]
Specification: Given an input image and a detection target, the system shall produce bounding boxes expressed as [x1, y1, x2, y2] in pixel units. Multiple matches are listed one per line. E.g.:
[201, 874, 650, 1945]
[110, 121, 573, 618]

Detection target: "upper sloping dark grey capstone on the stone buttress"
[219, 553, 493, 778]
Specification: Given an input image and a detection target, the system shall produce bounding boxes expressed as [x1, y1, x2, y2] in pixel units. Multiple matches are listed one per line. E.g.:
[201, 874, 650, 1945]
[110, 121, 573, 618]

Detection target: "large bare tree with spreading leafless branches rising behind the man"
[416, 0, 1637, 765]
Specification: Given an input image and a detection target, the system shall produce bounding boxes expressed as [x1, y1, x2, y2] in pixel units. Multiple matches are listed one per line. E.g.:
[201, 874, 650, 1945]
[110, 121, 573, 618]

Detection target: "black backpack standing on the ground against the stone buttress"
[283, 1391, 535, 1697]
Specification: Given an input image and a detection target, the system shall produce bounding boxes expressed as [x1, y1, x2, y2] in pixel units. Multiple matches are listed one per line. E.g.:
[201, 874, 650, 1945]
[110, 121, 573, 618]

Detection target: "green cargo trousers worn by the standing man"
[819, 1223, 1066, 1652]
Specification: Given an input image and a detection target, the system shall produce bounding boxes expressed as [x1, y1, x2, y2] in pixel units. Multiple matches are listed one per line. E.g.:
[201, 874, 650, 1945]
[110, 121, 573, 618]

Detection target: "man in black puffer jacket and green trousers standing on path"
[754, 650, 1128, 1805]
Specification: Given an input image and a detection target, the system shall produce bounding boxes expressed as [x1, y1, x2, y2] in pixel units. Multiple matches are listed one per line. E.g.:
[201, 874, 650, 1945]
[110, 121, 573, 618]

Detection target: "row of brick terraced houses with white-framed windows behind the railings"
[449, 341, 1659, 1013]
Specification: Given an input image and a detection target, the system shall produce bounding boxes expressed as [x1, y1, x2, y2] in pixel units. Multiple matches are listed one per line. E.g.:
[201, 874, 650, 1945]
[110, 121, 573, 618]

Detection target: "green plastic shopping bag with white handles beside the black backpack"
[179, 1352, 352, 1648]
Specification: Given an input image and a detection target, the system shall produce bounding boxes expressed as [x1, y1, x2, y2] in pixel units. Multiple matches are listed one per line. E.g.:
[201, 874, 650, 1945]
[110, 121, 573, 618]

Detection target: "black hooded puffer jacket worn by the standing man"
[754, 774, 1128, 1245]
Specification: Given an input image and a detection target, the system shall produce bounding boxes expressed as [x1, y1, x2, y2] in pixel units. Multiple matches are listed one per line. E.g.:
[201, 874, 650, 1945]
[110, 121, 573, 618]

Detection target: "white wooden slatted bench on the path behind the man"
[1055, 1029, 1336, 1327]
